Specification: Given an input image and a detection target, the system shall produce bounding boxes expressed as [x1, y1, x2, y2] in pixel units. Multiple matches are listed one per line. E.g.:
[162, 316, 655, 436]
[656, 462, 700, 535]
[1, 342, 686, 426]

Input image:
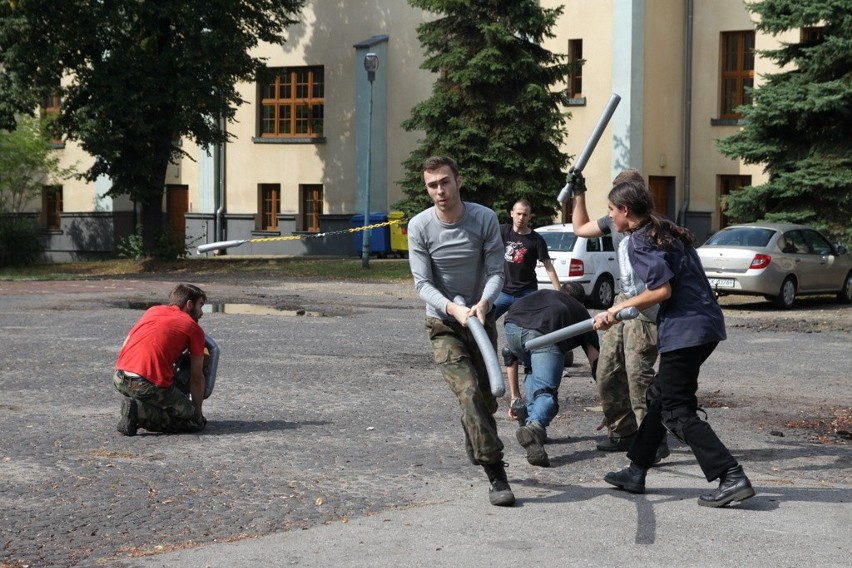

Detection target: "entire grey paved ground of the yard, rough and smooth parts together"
[0, 276, 852, 568]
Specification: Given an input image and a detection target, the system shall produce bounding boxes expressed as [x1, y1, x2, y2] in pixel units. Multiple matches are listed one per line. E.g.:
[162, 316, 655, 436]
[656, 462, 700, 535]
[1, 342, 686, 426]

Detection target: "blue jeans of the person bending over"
[503, 322, 565, 428]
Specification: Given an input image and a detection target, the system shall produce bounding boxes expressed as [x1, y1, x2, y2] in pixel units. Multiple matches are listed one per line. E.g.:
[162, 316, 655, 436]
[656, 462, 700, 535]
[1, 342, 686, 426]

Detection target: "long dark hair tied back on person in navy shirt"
[609, 169, 695, 250]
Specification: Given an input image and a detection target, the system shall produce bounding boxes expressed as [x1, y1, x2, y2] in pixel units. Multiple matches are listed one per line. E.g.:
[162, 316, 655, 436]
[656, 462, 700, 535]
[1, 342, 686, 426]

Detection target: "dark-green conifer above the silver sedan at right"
[719, 0, 852, 241]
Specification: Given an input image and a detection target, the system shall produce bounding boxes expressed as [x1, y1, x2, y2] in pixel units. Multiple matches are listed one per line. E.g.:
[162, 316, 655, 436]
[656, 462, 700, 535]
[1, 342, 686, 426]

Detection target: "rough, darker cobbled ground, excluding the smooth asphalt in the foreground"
[0, 274, 852, 568]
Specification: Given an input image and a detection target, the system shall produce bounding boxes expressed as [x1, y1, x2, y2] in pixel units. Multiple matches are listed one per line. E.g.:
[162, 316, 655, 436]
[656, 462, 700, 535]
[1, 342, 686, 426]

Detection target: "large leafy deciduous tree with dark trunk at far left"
[0, 0, 305, 250]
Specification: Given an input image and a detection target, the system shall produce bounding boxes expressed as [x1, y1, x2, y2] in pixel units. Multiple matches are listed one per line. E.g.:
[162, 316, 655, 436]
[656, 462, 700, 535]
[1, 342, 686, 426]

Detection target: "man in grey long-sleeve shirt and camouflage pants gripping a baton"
[408, 156, 515, 506]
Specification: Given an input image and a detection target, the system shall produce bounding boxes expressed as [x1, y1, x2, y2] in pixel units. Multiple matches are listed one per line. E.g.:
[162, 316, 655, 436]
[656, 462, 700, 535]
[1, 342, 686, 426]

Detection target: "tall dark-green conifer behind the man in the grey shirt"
[397, 0, 571, 223]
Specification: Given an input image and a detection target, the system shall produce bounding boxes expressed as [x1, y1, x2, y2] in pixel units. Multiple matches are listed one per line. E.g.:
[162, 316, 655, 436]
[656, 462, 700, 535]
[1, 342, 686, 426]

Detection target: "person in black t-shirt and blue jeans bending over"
[504, 282, 600, 467]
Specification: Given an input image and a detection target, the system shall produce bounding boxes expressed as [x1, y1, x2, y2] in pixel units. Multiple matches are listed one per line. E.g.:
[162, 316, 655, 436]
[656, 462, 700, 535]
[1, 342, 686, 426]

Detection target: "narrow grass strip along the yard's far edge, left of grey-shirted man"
[0, 256, 411, 282]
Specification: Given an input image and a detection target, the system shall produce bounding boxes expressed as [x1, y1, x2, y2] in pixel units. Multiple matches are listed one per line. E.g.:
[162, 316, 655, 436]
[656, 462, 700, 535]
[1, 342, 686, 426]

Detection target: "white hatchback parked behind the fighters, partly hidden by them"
[535, 223, 619, 309]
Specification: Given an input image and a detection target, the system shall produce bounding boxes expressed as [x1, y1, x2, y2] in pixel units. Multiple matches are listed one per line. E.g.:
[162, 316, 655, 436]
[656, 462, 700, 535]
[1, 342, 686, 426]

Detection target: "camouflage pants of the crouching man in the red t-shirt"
[112, 371, 206, 434]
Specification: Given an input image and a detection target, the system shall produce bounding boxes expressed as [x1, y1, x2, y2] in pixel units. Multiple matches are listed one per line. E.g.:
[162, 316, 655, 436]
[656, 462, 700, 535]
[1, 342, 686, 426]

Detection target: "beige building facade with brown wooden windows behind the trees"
[34, 0, 799, 260]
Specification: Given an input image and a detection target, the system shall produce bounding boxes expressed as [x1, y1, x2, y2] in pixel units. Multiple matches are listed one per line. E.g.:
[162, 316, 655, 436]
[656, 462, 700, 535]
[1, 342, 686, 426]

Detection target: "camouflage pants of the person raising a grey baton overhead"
[597, 300, 657, 438]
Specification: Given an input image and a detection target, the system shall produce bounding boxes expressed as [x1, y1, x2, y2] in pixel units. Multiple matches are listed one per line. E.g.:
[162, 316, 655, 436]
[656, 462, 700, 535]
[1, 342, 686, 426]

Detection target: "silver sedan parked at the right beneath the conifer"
[698, 223, 852, 309]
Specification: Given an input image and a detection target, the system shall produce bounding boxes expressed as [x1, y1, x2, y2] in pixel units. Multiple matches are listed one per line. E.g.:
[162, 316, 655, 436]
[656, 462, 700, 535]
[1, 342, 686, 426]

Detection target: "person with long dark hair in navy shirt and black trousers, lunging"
[595, 173, 754, 507]
